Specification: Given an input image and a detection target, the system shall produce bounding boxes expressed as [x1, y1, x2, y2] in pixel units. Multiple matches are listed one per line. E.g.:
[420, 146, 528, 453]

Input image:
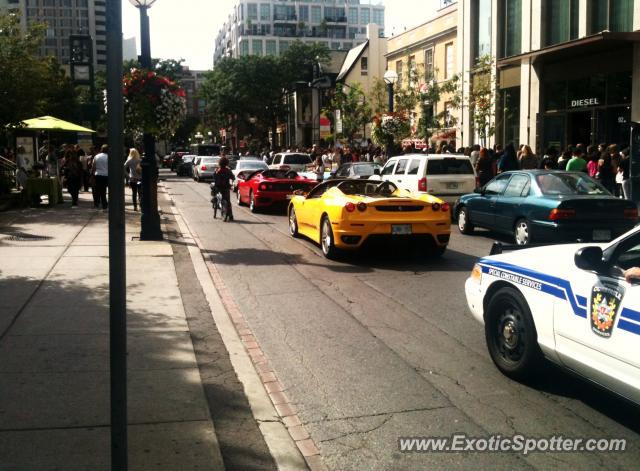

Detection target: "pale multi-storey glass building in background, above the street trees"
[213, 0, 384, 67]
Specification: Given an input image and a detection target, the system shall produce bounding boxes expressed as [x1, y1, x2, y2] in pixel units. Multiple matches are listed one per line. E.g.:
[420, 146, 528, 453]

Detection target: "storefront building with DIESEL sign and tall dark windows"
[458, 0, 640, 154]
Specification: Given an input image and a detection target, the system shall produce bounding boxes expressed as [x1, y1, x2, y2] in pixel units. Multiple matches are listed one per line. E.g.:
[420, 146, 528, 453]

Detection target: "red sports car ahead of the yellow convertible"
[237, 170, 318, 213]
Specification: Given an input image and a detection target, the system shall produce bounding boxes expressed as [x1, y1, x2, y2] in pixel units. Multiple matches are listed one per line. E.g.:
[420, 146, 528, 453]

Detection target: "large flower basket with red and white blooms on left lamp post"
[122, 69, 187, 138]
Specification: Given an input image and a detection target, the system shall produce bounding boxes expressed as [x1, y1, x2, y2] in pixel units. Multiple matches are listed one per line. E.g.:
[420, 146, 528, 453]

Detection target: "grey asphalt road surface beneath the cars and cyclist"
[165, 171, 640, 470]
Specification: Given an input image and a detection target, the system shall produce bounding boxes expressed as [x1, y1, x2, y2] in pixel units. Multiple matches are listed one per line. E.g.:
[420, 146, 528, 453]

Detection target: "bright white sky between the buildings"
[122, 0, 440, 70]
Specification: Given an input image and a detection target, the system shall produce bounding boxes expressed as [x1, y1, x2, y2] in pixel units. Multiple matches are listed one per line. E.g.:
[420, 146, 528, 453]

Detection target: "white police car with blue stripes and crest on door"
[465, 228, 640, 404]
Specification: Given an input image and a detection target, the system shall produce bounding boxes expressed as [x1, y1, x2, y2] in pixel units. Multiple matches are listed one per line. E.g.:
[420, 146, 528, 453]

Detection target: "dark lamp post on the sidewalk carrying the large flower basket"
[129, 0, 162, 240]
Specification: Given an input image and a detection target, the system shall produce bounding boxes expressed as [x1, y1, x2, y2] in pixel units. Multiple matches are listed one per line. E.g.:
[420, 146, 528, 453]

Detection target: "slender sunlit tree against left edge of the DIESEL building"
[469, 55, 496, 146]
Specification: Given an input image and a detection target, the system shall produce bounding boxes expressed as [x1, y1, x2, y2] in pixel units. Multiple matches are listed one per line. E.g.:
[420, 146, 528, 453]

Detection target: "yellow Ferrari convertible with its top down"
[289, 179, 451, 258]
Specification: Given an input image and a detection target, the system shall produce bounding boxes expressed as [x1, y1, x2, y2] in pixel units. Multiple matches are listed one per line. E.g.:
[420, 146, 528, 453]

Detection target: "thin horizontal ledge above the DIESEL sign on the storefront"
[497, 31, 640, 68]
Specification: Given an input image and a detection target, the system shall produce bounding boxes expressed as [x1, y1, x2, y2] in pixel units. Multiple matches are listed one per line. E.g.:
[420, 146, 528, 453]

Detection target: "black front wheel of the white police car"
[485, 287, 542, 380]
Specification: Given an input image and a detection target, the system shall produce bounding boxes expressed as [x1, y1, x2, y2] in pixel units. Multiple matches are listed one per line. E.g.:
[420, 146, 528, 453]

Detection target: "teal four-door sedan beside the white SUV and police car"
[454, 170, 638, 245]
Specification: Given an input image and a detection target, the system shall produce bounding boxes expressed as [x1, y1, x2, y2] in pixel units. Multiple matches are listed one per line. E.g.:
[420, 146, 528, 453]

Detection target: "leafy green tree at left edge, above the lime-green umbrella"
[0, 14, 78, 132]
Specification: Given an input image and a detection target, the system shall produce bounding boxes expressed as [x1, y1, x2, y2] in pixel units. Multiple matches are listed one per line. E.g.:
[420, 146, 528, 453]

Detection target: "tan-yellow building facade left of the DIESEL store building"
[386, 0, 461, 143]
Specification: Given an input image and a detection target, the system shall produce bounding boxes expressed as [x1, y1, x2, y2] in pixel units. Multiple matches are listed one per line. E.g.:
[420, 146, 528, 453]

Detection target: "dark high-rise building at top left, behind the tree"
[0, 0, 107, 70]
